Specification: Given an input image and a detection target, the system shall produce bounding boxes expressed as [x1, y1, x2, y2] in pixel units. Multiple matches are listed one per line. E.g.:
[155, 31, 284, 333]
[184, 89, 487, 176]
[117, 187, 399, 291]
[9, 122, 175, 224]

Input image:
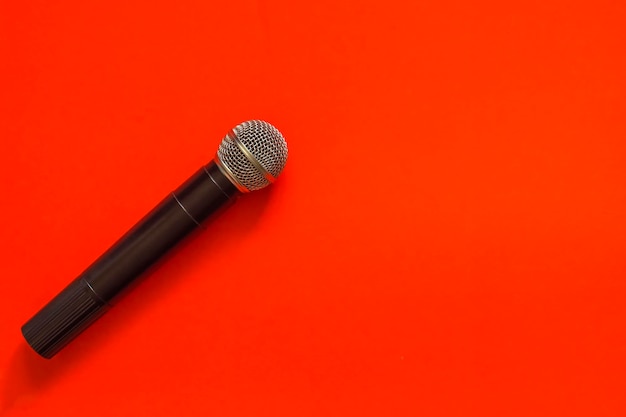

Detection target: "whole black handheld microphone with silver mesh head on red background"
[22, 120, 288, 359]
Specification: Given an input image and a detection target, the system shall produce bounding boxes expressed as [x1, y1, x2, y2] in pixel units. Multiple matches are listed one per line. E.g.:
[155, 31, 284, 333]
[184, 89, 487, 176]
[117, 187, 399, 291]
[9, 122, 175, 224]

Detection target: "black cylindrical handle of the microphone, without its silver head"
[22, 161, 240, 358]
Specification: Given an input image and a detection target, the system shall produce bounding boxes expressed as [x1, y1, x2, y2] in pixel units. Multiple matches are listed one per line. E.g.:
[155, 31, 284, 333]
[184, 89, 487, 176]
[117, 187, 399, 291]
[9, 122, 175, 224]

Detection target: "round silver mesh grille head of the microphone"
[217, 120, 287, 191]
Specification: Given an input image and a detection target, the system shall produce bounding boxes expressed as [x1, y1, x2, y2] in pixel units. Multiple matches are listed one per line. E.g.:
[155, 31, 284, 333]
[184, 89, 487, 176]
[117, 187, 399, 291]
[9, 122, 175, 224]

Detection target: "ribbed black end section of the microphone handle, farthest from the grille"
[22, 279, 107, 359]
